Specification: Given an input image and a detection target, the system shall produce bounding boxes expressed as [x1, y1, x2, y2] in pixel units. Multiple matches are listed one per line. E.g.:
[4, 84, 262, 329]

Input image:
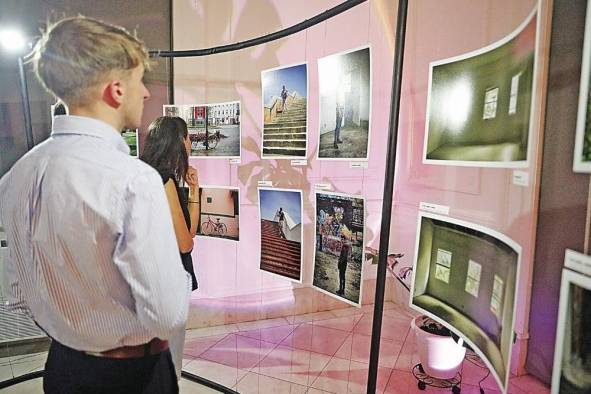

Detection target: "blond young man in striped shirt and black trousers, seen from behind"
[0, 17, 190, 394]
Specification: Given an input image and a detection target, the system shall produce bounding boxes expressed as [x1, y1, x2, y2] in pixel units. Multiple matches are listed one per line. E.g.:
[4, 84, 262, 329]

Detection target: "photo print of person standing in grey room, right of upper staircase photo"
[318, 47, 371, 160]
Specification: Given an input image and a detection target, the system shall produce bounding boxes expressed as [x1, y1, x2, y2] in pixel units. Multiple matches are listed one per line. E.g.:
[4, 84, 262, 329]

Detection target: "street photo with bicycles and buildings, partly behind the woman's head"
[162, 101, 240, 159]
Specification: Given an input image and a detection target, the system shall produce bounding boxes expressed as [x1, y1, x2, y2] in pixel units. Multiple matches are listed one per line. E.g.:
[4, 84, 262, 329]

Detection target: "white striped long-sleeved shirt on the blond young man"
[0, 116, 190, 352]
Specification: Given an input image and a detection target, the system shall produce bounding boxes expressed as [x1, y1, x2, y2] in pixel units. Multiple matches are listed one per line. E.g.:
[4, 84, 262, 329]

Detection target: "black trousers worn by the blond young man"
[43, 341, 179, 394]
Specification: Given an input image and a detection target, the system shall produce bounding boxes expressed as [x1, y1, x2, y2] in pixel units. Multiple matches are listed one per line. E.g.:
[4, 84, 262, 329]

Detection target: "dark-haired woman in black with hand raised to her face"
[140, 116, 200, 378]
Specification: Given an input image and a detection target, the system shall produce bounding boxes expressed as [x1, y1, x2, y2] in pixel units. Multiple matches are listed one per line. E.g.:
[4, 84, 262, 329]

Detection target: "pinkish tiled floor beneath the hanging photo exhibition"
[0, 303, 549, 394]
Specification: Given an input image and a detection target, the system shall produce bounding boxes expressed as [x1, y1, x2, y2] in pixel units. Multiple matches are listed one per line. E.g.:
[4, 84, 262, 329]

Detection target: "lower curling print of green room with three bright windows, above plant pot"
[410, 212, 521, 392]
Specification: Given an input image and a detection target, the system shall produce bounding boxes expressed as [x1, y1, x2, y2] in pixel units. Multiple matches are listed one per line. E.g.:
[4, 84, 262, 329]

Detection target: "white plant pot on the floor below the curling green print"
[411, 316, 466, 379]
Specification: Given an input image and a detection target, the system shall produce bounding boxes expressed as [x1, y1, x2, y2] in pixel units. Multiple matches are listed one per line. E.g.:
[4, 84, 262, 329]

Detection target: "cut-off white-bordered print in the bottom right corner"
[552, 269, 591, 394]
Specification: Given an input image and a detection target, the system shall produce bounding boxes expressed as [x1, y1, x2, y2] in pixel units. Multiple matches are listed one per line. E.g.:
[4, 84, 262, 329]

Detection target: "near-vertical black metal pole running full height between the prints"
[367, 0, 408, 394]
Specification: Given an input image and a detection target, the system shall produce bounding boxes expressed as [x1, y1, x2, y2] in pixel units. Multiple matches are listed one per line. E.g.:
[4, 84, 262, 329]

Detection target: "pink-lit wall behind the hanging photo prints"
[173, 0, 548, 376]
